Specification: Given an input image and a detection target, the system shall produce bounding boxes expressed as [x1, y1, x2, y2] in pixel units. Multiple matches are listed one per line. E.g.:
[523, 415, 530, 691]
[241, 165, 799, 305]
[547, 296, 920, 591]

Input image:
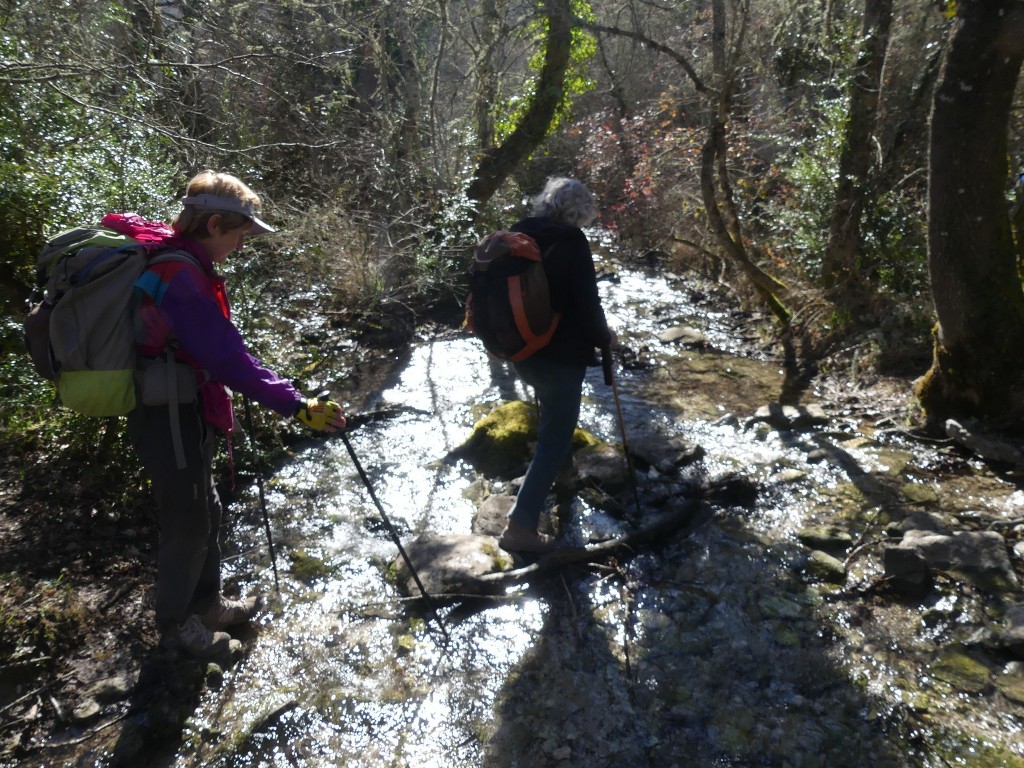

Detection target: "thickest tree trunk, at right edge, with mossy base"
[916, 0, 1024, 427]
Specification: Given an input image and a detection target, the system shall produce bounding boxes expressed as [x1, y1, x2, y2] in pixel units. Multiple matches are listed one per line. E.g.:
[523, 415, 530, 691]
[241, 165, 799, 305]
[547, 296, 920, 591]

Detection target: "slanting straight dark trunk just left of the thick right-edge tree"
[821, 0, 893, 294]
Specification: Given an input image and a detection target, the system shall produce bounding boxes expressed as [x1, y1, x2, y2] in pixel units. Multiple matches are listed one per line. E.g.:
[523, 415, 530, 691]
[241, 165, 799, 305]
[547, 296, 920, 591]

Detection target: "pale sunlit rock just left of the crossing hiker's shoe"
[394, 535, 512, 596]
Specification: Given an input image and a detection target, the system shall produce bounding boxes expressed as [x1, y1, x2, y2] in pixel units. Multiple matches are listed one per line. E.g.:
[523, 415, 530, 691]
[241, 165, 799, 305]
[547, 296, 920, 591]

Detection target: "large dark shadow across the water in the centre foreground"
[483, 364, 908, 768]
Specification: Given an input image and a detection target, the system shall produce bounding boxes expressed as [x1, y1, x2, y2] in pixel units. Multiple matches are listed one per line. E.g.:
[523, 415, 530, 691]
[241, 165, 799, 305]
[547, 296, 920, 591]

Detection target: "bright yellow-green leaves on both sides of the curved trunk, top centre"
[495, 0, 597, 141]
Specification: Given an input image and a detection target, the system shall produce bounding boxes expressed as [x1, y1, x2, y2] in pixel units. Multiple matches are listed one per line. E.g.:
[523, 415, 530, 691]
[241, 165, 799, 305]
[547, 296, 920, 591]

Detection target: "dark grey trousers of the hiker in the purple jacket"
[128, 401, 223, 632]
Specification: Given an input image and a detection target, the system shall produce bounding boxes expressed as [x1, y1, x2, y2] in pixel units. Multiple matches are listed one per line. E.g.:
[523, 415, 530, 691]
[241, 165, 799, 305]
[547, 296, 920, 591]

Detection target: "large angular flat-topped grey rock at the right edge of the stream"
[900, 530, 1018, 591]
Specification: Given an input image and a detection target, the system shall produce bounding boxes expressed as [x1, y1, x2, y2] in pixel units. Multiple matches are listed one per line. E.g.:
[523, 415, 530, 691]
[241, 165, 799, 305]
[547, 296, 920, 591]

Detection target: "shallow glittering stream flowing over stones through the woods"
[110, 240, 1024, 768]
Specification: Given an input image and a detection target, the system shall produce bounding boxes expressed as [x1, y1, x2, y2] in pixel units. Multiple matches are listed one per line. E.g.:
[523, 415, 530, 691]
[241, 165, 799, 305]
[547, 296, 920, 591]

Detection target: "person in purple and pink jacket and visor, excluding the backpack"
[112, 171, 345, 657]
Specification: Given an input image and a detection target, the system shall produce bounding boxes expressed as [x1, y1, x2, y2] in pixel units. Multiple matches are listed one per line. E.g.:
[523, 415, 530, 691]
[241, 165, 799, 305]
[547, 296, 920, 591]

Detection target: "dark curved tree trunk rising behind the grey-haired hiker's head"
[466, 0, 572, 212]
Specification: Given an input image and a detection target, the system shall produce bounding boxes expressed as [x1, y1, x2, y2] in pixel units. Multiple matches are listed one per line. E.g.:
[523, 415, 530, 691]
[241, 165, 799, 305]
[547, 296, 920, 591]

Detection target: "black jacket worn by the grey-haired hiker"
[510, 217, 611, 366]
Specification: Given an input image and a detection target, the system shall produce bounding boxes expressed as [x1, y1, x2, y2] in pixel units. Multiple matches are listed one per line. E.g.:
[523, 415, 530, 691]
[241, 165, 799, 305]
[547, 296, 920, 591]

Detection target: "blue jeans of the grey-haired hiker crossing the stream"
[509, 357, 587, 529]
